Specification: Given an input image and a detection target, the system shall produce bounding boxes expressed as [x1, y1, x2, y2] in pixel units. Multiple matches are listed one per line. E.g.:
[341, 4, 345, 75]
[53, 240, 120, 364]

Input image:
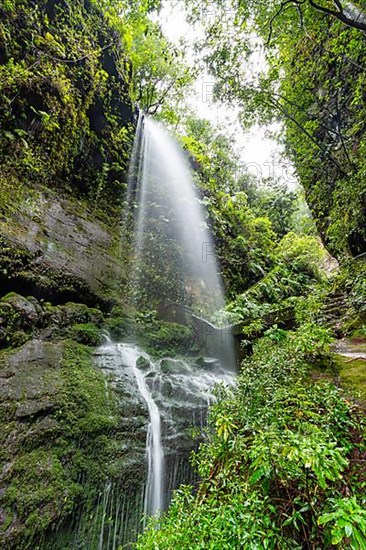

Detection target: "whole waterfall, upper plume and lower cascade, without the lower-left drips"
[118, 115, 234, 544]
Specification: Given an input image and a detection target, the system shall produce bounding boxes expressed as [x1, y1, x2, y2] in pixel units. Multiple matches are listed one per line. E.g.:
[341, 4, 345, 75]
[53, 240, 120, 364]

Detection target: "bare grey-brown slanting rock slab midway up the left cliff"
[0, 193, 124, 304]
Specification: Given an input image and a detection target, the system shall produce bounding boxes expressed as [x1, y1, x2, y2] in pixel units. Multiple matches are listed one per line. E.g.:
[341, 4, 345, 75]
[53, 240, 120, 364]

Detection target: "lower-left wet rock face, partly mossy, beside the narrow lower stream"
[0, 340, 147, 550]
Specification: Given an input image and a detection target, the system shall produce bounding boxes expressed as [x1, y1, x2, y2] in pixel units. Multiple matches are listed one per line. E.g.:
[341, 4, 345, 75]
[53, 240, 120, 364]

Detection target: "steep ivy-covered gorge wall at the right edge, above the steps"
[279, 14, 366, 259]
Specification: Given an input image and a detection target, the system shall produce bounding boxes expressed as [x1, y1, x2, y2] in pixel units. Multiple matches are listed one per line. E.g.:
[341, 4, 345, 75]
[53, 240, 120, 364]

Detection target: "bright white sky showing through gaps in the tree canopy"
[158, 0, 297, 188]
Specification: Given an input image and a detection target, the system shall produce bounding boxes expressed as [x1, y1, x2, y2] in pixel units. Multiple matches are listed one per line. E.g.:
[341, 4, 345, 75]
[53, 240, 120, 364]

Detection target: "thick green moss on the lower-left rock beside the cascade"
[0, 341, 124, 549]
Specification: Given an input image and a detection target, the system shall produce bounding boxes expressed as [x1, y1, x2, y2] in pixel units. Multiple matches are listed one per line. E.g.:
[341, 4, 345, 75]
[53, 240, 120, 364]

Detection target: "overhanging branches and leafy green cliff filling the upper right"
[186, 0, 366, 257]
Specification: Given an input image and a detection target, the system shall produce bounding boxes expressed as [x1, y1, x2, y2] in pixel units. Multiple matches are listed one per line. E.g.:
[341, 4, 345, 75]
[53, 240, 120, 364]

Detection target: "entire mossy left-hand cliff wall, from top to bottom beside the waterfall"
[0, 0, 147, 549]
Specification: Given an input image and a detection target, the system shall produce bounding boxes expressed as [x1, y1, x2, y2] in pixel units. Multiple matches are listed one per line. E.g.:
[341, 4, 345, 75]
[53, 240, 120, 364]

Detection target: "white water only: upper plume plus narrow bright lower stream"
[120, 114, 234, 544]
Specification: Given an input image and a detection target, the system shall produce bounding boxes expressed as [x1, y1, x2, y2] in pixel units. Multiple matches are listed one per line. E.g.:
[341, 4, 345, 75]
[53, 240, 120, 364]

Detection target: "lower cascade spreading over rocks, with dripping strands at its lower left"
[89, 342, 233, 550]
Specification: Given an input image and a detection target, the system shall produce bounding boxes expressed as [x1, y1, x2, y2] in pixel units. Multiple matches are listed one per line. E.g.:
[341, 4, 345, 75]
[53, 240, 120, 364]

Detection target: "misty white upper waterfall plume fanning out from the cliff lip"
[125, 115, 225, 315]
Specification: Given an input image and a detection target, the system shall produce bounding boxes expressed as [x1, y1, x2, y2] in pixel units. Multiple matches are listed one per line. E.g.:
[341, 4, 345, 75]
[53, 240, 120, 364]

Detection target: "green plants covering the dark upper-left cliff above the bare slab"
[0, 0, 132, 207]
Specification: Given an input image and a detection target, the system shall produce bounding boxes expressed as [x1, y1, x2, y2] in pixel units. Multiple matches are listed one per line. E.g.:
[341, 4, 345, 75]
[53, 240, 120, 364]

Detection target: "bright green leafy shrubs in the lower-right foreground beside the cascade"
[137, 327, 365, 550]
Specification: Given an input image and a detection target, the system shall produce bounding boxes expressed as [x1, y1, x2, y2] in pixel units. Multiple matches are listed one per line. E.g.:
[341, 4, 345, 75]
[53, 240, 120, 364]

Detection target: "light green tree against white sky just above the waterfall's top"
[95, 0, 194, 119]
